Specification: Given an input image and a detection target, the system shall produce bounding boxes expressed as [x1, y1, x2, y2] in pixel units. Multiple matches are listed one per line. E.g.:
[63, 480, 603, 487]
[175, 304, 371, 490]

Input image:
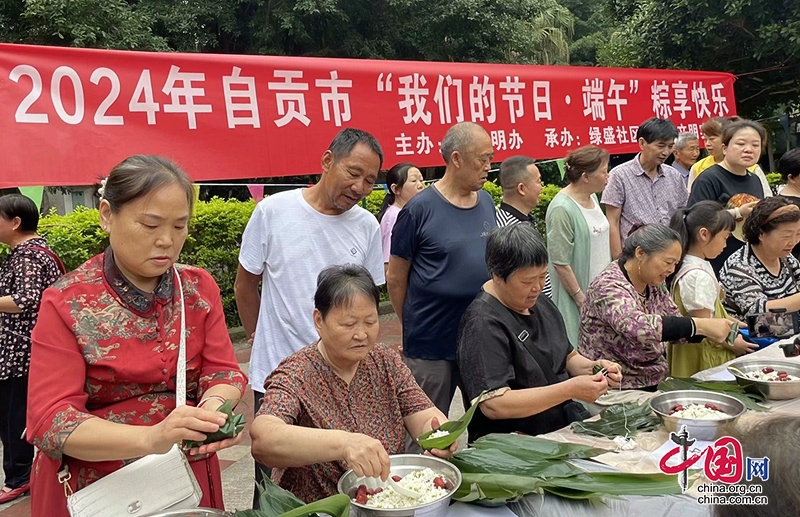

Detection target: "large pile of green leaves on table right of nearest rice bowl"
[451, 434, 681, 505]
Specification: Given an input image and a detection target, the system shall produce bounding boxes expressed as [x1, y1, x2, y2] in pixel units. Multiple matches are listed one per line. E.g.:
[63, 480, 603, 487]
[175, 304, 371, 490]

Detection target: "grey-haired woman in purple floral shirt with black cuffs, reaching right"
[579, 224, 732, 391]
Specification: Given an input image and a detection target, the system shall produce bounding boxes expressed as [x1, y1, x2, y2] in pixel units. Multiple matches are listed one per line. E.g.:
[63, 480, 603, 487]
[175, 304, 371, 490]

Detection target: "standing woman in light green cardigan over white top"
[545, 145, 611, 346]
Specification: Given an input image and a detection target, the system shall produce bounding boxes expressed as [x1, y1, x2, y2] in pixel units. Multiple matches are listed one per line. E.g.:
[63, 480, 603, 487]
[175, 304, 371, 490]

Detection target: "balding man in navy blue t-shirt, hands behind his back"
[387, 122, 497, 432]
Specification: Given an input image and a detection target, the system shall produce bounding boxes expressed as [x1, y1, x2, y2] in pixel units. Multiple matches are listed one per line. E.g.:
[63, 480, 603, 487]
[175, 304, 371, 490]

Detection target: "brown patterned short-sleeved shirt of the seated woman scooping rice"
[256, 344, 433, 503]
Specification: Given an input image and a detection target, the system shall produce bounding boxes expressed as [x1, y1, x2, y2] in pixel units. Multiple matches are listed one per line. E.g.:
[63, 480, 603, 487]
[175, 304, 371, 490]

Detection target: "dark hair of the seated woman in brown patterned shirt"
[314, 264, 381, 319]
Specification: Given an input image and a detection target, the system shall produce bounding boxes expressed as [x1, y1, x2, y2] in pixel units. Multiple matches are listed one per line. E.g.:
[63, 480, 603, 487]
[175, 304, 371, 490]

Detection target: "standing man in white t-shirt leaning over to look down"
[234, 128, 385, 499]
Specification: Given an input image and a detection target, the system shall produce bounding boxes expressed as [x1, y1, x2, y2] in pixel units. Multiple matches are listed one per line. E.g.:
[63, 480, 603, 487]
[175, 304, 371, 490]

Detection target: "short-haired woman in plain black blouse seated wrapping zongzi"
[456, 224, 622, 441]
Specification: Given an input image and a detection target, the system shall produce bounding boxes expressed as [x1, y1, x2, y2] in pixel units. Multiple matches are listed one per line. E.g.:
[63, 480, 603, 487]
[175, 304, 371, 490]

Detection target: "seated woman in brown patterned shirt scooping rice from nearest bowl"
[250, 264, 456, 503]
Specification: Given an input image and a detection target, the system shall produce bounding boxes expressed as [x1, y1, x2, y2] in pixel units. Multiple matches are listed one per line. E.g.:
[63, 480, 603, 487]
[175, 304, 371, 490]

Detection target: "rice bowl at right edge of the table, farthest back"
[728, 359, 800, 400]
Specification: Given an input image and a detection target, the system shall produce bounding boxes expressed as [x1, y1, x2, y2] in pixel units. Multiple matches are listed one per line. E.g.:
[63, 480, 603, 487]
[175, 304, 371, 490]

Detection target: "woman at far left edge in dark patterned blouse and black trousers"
[0, 194, 63, 504]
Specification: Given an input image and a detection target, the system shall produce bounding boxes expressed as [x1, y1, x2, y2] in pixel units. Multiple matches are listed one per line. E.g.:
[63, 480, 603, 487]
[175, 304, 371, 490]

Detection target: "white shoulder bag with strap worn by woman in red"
[58, 267, 203, 517]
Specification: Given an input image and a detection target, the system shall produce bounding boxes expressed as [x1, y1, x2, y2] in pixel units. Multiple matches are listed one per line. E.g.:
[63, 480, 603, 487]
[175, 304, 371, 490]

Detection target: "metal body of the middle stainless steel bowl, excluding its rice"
[650, 390, 747, 441]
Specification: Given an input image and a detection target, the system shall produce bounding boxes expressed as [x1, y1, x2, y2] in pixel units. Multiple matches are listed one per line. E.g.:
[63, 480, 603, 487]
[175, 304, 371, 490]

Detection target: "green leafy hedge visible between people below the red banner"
[9, 182, 560, 326]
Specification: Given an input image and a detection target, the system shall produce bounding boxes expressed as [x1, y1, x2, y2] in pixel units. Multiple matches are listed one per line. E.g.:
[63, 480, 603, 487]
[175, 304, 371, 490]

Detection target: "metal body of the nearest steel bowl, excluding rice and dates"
[338, 454, 461, 517]
